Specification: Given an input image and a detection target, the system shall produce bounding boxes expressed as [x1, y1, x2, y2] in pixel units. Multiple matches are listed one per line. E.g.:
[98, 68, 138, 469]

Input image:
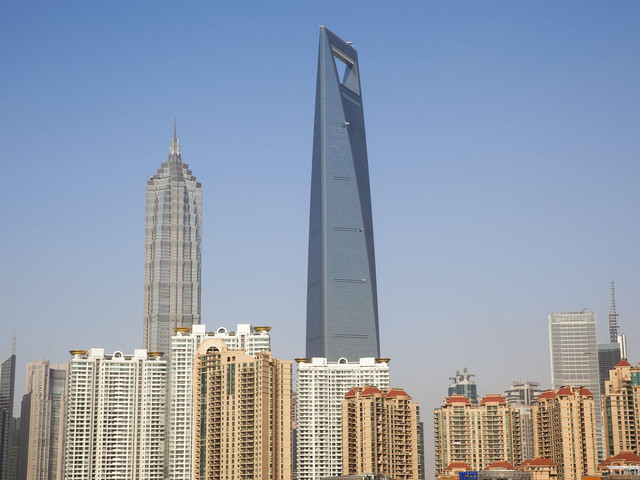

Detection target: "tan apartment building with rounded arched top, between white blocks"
[192, 338, 291, 480]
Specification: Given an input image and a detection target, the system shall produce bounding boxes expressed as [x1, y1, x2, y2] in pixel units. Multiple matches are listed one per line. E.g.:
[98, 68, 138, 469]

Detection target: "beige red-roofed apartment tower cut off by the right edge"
[602, 359, 640, 457]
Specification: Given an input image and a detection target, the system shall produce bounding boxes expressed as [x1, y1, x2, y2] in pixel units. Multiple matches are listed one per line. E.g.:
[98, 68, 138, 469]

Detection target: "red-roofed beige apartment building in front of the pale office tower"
[532, 386, 598, 480]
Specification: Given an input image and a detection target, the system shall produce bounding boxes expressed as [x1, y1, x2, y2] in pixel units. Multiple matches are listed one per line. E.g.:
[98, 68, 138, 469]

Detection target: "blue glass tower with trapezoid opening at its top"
[306, 27, 380, 361]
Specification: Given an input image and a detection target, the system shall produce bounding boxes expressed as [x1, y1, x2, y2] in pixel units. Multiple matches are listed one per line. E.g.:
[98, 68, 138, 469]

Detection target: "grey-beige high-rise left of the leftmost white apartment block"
[18, 360, 69, 480]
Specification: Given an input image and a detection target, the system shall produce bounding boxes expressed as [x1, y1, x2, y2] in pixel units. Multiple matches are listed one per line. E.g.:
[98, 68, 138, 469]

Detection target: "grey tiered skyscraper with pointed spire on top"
[144, 125, 202, 354]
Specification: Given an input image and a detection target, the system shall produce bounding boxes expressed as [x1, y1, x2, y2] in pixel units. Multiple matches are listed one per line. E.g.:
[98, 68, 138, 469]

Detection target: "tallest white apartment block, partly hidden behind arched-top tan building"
[166, 323, 271, 480]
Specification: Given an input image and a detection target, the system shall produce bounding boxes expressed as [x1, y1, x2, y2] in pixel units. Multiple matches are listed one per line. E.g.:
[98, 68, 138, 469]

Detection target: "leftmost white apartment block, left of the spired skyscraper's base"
[64, 348, 167, 480]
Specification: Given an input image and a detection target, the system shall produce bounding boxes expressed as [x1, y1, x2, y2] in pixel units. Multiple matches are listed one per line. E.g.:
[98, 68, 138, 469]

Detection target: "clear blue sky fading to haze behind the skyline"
[0, 0, 640, 476]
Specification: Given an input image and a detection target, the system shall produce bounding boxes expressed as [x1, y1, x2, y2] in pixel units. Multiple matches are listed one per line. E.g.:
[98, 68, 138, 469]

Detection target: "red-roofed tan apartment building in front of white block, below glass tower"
[342, 387, 422, 480]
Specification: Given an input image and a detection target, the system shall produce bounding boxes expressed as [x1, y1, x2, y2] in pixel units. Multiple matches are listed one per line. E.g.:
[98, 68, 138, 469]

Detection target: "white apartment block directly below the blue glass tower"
[296, 358, 389, 480]
